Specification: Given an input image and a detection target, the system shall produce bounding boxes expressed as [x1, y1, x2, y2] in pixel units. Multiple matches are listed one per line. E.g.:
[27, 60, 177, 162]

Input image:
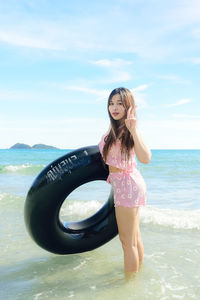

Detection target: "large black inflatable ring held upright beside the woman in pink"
[24, 146, 118, 254]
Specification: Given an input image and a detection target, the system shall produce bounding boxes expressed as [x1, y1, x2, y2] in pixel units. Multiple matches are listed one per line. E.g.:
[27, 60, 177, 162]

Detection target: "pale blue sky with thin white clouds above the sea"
[0, 0, 200, 149]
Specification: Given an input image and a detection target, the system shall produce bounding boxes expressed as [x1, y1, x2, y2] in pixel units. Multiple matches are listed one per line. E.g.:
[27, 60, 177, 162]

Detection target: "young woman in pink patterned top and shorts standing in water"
[99, 88, 151, 276]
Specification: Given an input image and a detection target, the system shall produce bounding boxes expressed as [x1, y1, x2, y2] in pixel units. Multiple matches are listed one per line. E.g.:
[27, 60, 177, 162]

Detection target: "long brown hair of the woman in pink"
[103, 87, 135, 161]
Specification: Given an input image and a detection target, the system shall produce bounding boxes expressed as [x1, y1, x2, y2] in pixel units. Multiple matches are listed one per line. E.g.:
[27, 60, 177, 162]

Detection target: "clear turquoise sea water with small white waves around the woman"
[0, 150, 200, 300]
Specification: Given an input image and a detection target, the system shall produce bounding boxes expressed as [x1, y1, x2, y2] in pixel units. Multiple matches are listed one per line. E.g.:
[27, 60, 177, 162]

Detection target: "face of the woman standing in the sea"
[108, 94, 125, 121]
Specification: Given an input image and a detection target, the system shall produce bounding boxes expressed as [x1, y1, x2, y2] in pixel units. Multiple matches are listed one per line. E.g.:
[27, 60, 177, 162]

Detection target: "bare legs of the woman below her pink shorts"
[115, 206, 143, 273]
